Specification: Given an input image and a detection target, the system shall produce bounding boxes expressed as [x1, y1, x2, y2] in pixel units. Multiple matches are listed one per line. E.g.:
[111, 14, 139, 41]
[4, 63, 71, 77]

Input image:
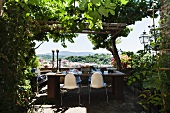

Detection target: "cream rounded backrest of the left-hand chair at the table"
[63, 73, 77, 89]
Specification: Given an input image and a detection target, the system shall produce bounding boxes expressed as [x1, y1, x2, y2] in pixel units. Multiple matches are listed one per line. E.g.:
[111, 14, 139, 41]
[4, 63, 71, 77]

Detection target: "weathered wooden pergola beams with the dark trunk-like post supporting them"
[40, 21, 127, 70]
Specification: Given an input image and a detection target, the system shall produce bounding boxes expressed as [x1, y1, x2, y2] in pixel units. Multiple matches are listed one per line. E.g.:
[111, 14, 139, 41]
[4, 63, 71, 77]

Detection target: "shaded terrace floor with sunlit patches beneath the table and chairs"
[28, 86, 146, 113]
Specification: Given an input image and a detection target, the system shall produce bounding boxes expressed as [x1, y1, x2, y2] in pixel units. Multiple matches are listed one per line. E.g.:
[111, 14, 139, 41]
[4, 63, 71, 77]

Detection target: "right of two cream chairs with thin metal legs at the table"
[89, 72, 108, 104]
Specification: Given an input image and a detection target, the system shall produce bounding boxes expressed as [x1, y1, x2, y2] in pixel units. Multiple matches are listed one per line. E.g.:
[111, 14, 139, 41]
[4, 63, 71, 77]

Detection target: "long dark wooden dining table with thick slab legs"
[46, 71, 126, 100]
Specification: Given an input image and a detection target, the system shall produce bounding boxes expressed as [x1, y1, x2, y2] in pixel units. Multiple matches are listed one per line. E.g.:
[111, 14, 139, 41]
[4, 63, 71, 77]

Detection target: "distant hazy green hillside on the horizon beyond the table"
[37, 51, 111, 64]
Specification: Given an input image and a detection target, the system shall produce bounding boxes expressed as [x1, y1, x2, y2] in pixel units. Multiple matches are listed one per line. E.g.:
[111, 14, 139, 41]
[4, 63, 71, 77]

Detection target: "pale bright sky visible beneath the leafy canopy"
[36, 18, 159, 54]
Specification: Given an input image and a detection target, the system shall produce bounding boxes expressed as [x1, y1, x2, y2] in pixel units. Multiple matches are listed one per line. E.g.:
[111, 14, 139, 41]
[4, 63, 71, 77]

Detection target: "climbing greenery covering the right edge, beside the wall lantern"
[128, 2, 170, 113]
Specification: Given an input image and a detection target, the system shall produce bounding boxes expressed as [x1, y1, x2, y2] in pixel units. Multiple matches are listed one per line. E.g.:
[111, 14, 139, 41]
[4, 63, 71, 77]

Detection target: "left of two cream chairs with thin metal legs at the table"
[61, 73, 80, 106]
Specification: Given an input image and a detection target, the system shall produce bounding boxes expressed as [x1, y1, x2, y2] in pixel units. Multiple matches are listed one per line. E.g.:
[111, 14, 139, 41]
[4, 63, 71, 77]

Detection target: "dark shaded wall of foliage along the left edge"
[0, 4, 34, 113]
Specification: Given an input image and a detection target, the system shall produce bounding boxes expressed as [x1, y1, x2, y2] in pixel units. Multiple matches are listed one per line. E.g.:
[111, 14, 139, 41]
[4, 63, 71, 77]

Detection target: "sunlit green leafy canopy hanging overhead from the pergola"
[6, 0, 128, 47]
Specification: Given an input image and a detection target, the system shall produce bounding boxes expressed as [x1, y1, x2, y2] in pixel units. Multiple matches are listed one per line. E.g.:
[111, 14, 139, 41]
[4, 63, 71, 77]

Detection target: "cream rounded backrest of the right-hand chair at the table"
[91, 72, 104, 88]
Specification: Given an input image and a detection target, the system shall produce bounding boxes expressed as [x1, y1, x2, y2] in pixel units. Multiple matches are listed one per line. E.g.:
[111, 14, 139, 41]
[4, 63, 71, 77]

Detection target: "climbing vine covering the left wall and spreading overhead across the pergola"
[0, 0, 127, 113]
